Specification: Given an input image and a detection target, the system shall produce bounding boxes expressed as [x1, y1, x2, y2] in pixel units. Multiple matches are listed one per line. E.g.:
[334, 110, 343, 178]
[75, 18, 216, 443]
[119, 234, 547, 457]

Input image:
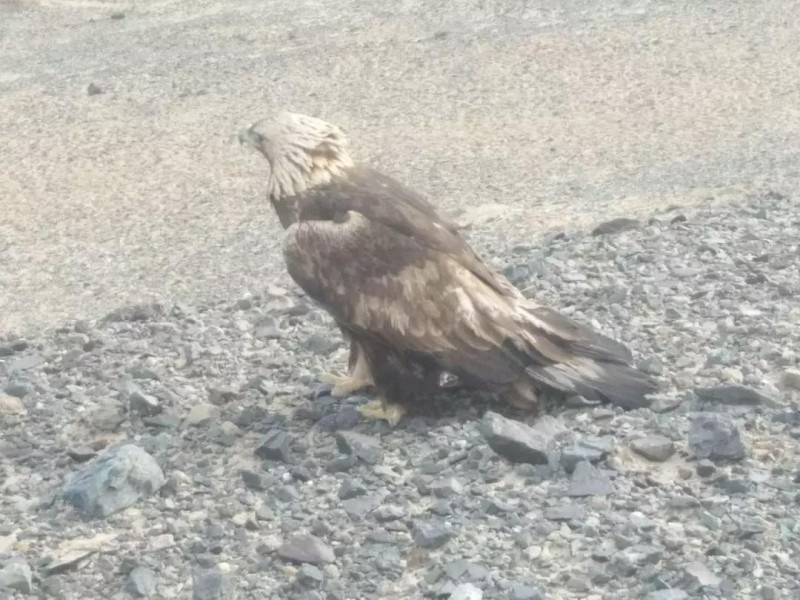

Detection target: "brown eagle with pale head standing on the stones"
[239, 112, 656, 425]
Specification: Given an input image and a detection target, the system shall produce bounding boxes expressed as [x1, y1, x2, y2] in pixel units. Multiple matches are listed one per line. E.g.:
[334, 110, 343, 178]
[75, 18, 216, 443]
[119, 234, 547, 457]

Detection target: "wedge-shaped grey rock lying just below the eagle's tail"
[479, 411, 566, 465]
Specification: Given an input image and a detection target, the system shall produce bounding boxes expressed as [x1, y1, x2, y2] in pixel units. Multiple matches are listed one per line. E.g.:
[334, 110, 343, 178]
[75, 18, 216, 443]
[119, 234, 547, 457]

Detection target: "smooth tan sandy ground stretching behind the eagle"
[0, 0, 800, 332]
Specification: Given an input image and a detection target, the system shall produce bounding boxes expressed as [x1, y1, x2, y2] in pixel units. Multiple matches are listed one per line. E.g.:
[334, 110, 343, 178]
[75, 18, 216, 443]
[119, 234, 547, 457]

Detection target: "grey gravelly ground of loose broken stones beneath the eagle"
[0, 192, 800, 600]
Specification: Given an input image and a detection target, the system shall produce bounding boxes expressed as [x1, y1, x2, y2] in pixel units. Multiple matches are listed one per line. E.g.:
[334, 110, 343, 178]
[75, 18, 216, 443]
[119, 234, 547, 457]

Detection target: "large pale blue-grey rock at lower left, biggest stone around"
[63, 444, 166, 518]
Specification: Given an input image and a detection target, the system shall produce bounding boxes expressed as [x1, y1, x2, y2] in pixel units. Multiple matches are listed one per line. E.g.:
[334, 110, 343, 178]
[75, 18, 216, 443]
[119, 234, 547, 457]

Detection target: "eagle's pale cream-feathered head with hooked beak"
[239, 112, 353, 211]
